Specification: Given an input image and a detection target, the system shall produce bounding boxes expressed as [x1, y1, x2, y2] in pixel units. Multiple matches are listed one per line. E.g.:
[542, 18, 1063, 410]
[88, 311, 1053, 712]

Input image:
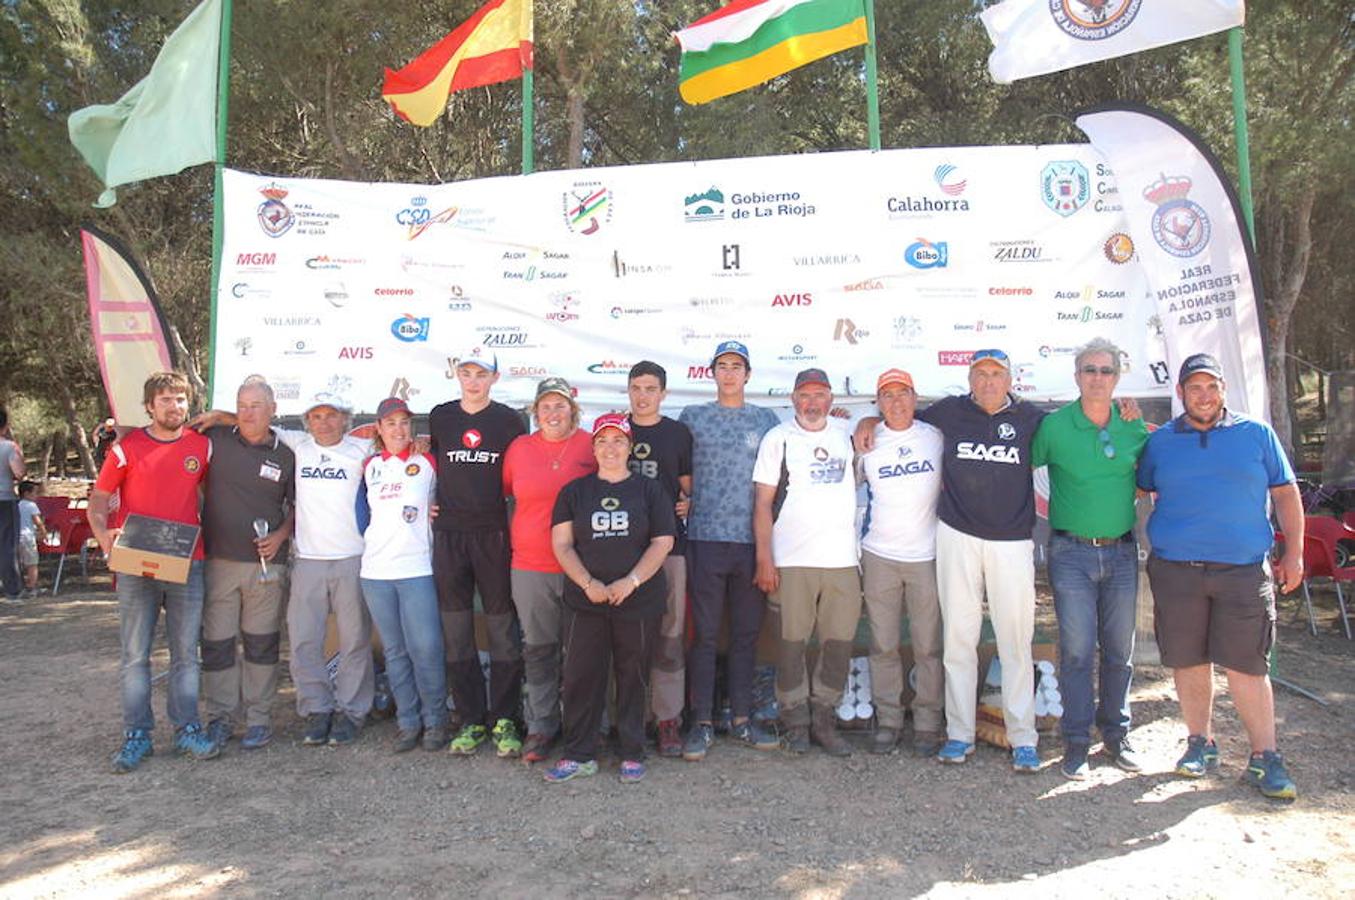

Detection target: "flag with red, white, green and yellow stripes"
[673, 0, 867, 104]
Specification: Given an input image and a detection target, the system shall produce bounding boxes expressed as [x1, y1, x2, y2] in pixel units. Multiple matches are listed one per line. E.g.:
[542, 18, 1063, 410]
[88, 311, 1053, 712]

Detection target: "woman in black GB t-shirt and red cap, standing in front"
[545, 413, 678, 782]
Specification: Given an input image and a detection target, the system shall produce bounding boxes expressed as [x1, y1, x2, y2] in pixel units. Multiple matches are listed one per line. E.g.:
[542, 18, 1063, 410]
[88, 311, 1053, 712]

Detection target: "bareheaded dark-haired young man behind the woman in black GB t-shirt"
[627, 359, 692, 756]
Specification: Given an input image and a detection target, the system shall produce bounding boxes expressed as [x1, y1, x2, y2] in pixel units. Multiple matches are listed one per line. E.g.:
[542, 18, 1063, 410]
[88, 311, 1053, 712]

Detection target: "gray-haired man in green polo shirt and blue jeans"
[1031, 338, 1148, 781]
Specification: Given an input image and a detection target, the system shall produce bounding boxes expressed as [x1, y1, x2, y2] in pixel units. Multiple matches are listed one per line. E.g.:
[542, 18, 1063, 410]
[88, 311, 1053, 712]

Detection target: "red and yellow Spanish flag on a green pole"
[381, 0, 531, 127]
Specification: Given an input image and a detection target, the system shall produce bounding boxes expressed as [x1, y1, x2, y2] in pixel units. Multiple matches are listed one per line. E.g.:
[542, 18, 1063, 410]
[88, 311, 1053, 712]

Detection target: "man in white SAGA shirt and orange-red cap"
[858, 369, 946, 756]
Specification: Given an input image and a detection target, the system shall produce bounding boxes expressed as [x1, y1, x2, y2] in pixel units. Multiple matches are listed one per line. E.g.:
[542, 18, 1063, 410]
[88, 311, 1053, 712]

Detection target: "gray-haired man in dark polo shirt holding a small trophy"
[202, 375, 297, 750]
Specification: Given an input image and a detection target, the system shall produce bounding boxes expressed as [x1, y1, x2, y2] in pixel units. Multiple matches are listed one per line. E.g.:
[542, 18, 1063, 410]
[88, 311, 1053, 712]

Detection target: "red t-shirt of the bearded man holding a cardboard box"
[93, 428, 211, 560]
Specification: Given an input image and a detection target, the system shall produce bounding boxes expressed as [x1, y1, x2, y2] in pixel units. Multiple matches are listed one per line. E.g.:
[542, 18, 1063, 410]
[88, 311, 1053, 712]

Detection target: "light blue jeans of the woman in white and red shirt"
[362, 575, 447, 731]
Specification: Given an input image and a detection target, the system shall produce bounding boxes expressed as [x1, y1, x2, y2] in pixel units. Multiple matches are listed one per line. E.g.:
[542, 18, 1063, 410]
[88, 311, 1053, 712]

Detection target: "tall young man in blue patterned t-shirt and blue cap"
[679, 340, 778, 762]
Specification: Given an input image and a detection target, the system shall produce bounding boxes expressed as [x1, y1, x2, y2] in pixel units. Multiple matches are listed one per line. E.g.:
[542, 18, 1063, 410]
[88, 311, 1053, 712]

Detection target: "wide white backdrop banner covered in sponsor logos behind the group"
[211, 144, 1194, 415]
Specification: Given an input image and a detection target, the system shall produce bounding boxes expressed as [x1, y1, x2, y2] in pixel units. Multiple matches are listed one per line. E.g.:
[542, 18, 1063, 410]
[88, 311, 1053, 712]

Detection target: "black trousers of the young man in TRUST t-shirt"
[432, 531, 522, 727]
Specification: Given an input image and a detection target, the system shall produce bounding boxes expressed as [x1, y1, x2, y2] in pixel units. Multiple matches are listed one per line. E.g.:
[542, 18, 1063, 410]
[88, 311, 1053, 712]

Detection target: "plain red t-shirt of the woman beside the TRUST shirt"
[504, 430, 598, 572]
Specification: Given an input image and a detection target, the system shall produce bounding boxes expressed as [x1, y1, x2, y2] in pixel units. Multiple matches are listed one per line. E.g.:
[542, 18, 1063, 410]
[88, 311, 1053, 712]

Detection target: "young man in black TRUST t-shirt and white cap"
[424, 347, 527, 758]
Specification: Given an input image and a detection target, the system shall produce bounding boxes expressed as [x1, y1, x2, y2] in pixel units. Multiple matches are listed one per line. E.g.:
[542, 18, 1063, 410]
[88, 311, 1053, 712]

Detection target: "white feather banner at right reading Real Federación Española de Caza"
[1077, 108, 1270, 422]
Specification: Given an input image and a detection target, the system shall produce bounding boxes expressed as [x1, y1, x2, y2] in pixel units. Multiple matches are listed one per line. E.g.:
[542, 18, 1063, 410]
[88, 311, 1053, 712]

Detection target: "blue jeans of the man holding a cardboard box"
[118, 560, 203, 731]
